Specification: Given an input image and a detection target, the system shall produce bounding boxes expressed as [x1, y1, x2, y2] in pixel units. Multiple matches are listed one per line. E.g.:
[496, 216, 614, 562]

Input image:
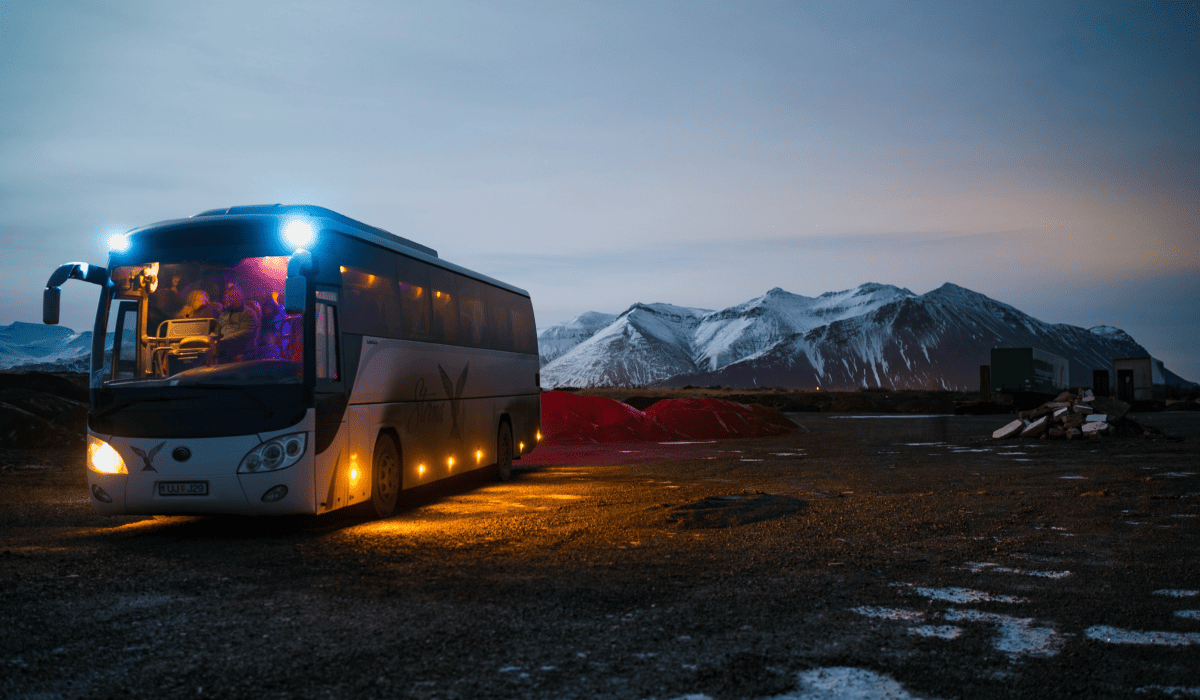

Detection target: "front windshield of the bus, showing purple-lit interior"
[102, 256, 304, 387]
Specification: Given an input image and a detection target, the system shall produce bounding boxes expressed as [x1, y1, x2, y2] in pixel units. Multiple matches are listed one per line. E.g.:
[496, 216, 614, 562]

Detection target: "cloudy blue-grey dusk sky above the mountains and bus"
[0, 0, 1200, 381]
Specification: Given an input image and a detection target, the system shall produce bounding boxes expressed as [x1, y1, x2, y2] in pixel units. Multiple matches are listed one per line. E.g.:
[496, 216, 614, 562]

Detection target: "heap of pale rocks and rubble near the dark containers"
[991, 389, 1162, 439]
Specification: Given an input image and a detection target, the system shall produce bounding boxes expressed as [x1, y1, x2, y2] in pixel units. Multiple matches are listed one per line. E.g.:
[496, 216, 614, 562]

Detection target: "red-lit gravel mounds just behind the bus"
[541, 391, 796, 444]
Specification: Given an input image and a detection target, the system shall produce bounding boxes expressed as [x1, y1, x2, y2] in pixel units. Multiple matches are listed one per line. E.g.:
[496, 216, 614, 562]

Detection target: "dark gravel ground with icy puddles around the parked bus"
[0, 413, 1200, 699]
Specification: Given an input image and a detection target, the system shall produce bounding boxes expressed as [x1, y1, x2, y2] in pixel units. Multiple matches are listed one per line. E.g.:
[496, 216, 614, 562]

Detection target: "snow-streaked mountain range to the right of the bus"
[542, 283, 1187, 390]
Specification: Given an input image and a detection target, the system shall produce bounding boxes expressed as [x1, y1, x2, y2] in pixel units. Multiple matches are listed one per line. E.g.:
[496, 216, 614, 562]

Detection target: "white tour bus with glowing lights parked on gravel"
[43, 204, 541, 517]
